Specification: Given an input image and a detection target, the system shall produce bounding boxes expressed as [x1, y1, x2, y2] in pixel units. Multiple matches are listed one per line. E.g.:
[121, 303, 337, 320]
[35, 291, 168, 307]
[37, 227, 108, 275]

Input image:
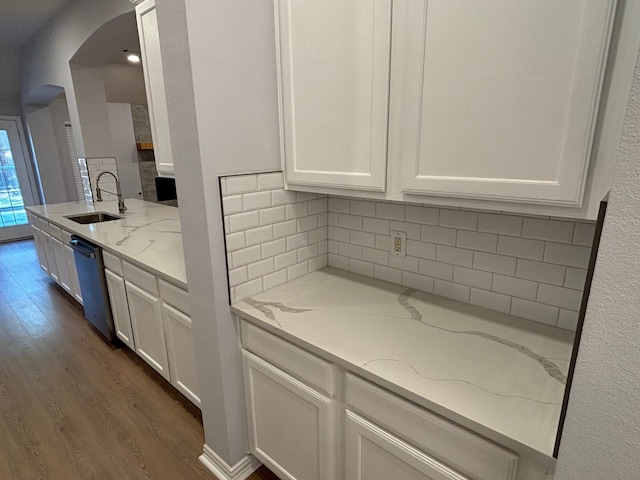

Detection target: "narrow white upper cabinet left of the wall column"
[136, 0, 174, 177]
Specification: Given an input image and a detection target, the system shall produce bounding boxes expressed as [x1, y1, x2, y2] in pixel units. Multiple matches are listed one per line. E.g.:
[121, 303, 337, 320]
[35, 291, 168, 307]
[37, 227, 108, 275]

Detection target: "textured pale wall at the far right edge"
[555, 45, 640, 480]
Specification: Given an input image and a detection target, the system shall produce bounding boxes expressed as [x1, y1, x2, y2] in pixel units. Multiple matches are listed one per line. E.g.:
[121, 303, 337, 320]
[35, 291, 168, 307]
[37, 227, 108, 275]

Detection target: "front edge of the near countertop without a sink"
[230, 305, 556, 468]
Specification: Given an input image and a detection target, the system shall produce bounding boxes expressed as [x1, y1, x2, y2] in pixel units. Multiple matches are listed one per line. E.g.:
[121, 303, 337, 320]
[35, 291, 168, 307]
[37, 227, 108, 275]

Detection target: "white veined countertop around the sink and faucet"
[27, 199, 187, 289]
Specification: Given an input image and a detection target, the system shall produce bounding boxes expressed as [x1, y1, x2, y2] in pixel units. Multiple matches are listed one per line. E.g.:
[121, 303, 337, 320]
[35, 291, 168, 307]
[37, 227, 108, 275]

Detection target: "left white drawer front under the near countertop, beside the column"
[241, 321, 334, 395]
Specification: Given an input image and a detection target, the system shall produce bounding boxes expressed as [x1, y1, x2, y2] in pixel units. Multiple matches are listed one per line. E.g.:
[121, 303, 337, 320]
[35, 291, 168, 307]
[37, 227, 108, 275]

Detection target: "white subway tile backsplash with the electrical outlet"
[327, 197, 595, 330]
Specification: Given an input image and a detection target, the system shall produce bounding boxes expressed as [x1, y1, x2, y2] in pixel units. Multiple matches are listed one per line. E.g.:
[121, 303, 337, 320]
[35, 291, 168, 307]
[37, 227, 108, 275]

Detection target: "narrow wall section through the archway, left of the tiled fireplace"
[107, 103, 142, 200]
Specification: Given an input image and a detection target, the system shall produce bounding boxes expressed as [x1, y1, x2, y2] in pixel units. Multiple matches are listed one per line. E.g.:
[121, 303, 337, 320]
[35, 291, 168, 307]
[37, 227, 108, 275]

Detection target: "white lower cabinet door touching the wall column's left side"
[162, 303, 200, 406]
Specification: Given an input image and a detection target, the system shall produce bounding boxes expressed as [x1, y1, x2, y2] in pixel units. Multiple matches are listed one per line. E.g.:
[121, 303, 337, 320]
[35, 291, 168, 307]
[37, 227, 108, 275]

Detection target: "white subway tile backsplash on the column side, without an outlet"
[220, 172, 327, 303]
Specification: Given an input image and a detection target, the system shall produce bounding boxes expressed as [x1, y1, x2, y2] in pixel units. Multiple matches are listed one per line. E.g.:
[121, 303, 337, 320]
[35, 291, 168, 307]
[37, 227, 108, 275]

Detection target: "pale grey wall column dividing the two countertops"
[156, 0, 280, 465]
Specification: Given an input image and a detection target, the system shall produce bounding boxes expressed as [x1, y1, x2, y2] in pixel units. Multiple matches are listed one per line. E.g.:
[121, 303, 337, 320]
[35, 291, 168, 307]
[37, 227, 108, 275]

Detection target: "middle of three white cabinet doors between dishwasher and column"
[125, 280, 170, 380]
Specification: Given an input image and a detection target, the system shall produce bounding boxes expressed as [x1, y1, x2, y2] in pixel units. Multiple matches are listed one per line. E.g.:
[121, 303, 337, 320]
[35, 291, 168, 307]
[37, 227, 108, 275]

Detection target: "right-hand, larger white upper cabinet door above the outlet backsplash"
[389, 0, 616, 206]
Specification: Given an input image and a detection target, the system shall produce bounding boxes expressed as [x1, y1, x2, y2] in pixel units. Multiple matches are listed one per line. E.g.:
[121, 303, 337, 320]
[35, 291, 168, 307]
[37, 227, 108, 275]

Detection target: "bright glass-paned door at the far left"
[0, 117, 35, 242]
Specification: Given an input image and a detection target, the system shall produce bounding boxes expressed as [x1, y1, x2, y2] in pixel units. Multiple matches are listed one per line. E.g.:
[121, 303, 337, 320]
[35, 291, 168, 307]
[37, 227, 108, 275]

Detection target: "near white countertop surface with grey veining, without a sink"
[232, 268, 573, 461]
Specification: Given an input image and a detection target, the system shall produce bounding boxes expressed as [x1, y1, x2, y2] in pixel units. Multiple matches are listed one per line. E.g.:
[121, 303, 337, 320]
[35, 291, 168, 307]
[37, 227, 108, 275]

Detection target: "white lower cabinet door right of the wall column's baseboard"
[242, 351, 336, 480]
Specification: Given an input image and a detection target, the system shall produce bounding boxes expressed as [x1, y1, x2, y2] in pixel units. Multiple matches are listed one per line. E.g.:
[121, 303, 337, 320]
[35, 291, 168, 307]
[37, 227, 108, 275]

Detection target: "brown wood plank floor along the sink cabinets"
[0, 240, 276, 480]
